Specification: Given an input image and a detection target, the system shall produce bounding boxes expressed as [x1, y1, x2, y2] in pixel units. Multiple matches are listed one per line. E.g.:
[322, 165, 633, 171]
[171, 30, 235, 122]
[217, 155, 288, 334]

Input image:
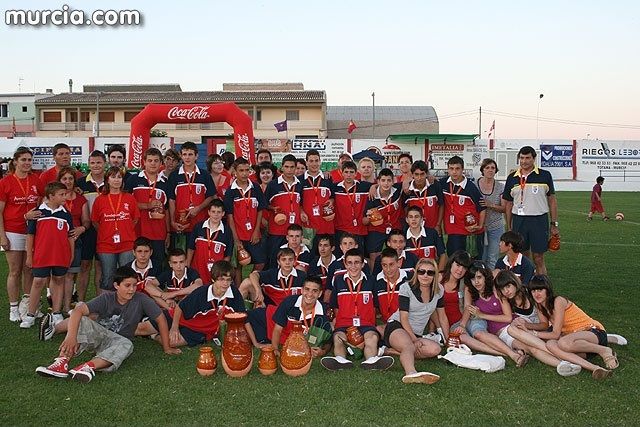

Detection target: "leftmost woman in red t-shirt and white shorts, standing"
[0, 147, 44, 322]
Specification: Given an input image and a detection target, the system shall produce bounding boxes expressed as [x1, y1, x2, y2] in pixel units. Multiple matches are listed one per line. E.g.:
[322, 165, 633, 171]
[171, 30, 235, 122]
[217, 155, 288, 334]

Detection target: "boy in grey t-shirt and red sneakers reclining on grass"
[36, 266, 181, 383]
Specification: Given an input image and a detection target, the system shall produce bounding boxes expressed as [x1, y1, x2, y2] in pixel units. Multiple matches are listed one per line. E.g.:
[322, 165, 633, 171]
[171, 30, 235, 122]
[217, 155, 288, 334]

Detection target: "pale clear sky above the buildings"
[0, 0, 640, 140]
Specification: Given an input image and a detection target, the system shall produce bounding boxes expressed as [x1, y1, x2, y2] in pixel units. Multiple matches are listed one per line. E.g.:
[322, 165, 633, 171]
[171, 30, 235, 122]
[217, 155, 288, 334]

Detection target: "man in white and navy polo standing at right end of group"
[502, 146, 560, 274]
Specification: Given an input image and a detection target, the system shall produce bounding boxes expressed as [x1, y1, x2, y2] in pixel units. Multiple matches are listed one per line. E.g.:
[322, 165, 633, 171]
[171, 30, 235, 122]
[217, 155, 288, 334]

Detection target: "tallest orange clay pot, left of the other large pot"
[221, 313, 253, 377]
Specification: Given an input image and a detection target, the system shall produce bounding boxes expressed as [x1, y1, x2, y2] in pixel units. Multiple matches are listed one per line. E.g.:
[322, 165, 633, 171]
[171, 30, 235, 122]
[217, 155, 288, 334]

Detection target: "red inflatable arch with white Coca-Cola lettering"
[127, 102, 255, 169]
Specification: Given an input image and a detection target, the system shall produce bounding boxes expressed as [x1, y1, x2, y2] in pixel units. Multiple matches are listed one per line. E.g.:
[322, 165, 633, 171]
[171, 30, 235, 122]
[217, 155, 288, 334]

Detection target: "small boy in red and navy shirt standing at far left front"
[20, 182, 75, 329]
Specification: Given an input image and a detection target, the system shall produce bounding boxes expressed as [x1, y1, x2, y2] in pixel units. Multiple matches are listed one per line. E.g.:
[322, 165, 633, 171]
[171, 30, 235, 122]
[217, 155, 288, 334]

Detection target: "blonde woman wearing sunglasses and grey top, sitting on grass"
[384, 258, 446, 384]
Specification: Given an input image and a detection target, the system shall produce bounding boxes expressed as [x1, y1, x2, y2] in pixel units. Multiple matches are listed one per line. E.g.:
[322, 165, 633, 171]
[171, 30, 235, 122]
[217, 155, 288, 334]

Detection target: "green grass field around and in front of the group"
[0, 192, 640, 426]
